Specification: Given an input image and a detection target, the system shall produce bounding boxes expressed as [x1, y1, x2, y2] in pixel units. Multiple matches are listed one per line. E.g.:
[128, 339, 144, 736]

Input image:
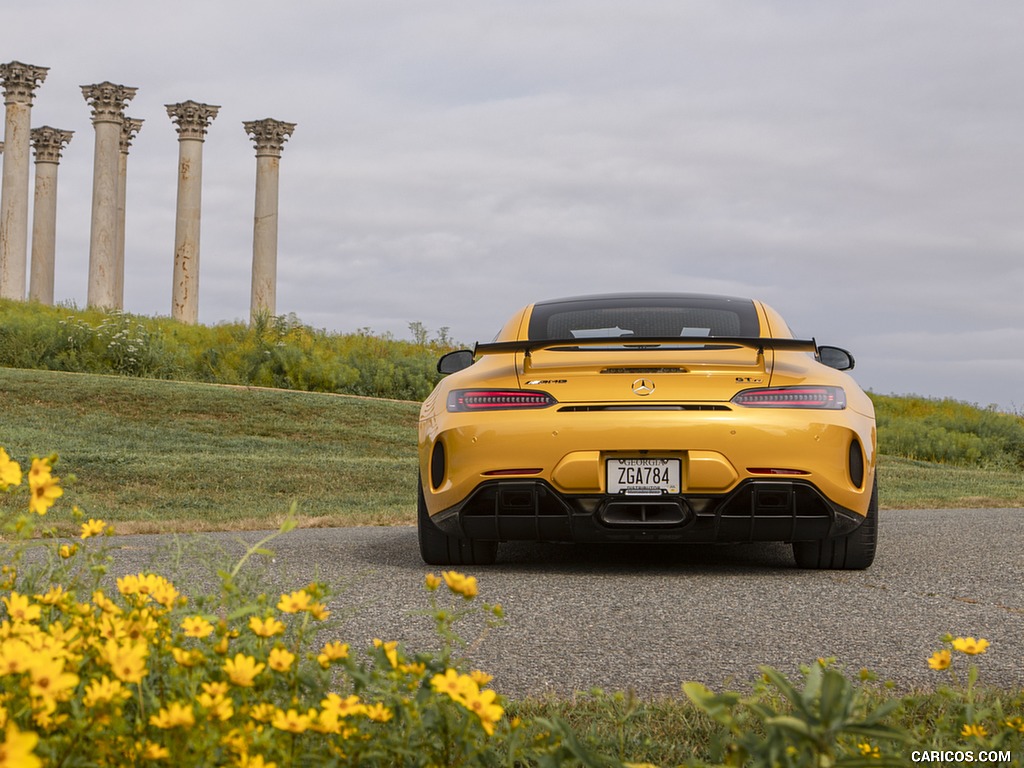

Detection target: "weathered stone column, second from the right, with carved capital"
[167, 101, 220, 324]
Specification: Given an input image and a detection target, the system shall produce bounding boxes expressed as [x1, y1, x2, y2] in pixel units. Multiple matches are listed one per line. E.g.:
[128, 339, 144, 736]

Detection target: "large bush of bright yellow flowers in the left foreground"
[0, 449, 597, 768]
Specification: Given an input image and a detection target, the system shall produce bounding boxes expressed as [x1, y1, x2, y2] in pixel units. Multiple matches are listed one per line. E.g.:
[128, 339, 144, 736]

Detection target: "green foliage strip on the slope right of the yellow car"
[871, 394, 1024, 469]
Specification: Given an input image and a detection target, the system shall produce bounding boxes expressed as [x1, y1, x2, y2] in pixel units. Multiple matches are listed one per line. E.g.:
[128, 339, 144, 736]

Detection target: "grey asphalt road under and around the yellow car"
[99, 509, 1024, 697]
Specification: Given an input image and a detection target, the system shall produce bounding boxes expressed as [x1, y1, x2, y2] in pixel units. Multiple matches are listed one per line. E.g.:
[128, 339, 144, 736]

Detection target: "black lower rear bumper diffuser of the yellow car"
[432, 479, 864, 543]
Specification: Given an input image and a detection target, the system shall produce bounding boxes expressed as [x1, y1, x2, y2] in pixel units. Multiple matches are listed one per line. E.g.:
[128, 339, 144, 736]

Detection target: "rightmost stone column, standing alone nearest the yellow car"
[242, 118, 295, 319]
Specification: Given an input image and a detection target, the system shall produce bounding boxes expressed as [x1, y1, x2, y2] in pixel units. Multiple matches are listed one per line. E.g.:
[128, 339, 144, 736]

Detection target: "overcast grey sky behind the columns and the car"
[0, 0, 1024, 412]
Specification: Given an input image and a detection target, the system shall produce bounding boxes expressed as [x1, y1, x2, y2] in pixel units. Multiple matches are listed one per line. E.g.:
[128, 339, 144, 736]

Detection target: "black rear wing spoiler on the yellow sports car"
[473, 336, 818, 357]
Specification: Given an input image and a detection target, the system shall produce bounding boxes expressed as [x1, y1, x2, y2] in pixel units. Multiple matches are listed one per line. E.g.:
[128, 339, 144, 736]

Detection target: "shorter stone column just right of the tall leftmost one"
[29, 125, 75, 304]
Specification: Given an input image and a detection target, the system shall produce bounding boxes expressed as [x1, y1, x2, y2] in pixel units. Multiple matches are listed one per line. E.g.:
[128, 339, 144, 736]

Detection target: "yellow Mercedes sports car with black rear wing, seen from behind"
[418, 293, 878, 568]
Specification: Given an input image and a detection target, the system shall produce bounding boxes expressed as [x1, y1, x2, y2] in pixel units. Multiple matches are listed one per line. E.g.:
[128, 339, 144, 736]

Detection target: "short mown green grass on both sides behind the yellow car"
[0, 369, 1024, 532]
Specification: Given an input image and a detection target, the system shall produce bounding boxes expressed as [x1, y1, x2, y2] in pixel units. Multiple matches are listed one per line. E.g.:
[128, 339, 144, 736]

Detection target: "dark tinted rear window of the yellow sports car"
[529, 296, 761, 341]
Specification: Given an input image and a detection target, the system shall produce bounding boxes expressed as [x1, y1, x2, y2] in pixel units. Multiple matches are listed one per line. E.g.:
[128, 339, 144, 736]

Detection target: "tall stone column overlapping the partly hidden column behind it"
[82, 82, 138, 309]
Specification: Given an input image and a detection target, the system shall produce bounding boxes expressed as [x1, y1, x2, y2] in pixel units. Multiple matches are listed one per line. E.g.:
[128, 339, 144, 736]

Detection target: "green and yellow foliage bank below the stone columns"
[0, 301, 455, 400]
